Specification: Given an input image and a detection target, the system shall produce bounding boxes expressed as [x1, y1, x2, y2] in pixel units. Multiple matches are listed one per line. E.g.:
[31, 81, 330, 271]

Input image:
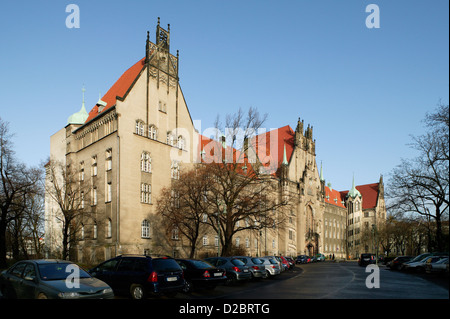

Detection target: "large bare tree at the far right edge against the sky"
[388, 105, 449, 254]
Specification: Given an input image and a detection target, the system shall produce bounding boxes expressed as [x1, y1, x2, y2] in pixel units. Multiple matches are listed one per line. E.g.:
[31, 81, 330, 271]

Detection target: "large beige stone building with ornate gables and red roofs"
[45, 20, 386, 263]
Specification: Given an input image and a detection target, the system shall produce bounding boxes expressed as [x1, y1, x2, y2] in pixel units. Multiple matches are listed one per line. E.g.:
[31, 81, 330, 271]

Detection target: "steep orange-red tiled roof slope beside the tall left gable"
[85, 58, 145, 123]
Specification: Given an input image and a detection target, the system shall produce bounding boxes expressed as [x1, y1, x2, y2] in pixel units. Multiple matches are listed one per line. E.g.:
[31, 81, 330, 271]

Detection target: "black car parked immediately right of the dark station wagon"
[176, 259, 227, 293]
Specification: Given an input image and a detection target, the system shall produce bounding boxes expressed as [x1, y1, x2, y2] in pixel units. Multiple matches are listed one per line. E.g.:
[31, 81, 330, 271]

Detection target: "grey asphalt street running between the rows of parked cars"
[177, 262, 449, 299]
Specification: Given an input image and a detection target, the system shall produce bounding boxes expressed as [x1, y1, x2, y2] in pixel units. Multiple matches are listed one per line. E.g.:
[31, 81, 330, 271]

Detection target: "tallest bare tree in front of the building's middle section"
[203, 108, 289, 255]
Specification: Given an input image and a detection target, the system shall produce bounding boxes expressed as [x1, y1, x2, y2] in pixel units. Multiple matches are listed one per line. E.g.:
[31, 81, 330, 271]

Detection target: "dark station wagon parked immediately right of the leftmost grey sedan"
[89, 255, 185, 299]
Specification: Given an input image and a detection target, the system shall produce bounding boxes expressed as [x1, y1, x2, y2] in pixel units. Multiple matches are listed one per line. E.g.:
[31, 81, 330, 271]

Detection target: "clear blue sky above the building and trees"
[0, 0, 449, 190]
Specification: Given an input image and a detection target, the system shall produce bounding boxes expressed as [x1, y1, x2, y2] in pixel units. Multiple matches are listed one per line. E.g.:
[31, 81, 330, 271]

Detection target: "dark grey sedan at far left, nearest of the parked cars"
[0, 259, 114, 299]
